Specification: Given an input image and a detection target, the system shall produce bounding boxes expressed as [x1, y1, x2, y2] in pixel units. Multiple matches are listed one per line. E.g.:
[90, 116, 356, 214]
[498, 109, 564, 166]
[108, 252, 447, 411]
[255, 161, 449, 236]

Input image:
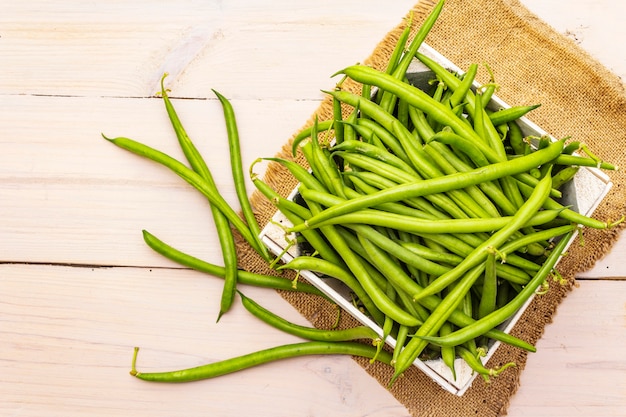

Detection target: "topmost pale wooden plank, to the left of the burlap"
[0, 0, 415, 100]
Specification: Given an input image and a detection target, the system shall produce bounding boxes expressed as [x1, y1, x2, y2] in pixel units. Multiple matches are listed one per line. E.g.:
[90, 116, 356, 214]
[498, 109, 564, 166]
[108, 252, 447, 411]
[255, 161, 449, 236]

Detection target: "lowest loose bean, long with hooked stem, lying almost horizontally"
[130, 342, 391, 382]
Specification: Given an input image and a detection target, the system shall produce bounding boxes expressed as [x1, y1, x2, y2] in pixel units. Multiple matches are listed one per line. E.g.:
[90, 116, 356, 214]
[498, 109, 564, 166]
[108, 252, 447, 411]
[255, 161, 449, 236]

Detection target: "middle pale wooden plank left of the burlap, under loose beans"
[0, 96, 318, 266]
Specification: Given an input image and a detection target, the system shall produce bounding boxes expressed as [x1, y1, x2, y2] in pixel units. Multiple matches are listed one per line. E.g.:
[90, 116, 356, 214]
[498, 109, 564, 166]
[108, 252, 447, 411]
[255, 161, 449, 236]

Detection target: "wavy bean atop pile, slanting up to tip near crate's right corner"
[415, 171, 552, 299]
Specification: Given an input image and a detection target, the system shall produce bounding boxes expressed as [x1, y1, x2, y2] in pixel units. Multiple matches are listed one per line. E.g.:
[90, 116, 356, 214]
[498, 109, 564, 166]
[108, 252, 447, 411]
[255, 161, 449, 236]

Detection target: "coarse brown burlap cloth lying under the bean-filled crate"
[240, 0, 626, 417]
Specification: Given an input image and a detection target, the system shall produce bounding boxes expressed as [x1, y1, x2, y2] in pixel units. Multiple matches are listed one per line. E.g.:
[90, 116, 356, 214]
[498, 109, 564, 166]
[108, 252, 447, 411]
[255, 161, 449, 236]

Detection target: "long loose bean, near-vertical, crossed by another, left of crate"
[161, 75, 238, 321]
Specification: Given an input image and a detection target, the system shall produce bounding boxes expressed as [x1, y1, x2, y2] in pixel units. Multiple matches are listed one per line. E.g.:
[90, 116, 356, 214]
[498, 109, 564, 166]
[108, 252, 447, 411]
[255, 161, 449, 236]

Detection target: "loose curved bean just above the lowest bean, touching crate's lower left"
[239, 291, 380, 342]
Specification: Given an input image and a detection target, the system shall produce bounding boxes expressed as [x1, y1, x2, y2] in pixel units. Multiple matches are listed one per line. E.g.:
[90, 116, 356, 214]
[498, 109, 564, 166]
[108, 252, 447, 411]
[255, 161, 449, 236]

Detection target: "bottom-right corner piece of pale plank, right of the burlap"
[508, 281, 626, 417]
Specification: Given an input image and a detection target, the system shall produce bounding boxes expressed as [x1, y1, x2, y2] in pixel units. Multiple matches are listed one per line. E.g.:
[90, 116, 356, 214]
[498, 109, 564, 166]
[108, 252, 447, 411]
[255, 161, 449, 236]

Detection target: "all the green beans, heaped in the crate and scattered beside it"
[110, 1, 617, 383]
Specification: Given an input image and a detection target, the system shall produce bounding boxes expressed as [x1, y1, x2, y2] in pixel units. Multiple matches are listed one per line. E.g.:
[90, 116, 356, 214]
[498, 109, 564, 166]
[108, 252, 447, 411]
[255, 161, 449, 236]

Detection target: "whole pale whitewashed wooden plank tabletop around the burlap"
[0, 0, 626, 417]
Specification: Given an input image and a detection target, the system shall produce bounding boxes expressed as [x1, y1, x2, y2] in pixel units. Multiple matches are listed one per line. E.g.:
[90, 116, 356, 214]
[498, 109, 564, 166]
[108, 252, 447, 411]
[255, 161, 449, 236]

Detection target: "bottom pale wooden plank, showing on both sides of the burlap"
[0, 265, 626, 417]
